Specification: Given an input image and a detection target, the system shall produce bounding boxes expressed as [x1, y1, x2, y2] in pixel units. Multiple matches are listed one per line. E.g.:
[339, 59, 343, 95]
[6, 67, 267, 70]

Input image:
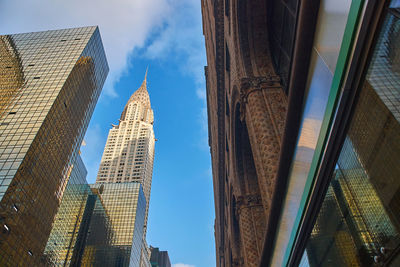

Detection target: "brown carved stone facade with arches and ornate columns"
[202, 0, 287, 266]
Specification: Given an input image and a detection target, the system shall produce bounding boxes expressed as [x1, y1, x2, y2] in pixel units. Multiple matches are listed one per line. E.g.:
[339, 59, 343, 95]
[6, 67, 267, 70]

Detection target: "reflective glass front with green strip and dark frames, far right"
[269, 0, 400, 267]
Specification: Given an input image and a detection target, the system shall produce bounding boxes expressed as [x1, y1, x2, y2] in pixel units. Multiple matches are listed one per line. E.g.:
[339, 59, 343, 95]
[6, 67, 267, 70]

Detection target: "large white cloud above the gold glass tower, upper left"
[0, 0, 171, 97]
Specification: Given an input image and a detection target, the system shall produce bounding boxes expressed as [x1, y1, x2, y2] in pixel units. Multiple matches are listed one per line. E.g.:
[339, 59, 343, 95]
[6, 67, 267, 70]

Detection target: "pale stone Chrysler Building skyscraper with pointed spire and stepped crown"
[96, 71, 155, 233]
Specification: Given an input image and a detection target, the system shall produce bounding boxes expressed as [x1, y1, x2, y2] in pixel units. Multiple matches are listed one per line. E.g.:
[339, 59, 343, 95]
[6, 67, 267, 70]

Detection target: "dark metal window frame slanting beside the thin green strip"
[287, 0, 390, 266]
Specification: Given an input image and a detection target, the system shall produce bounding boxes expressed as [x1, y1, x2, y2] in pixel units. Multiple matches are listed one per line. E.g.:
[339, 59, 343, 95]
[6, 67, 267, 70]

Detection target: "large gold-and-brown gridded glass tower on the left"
[0, 27, 108, 266]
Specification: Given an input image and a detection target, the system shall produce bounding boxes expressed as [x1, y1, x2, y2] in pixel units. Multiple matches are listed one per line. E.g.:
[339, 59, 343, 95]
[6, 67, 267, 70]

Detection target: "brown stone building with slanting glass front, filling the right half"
[202, 0, 400, 267]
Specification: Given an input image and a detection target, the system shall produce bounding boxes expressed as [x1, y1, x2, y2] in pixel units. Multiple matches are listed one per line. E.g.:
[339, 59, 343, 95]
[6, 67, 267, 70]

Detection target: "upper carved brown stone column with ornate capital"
[240, 75, 287, 216]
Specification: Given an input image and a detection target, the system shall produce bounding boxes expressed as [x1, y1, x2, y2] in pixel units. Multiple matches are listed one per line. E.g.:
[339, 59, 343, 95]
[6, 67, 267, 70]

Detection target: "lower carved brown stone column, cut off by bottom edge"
[235, 195, 265, 267]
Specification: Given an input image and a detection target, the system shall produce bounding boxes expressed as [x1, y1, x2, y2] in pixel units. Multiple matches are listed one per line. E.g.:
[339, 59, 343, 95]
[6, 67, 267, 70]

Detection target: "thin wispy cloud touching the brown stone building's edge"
[144, 0, 208, 149]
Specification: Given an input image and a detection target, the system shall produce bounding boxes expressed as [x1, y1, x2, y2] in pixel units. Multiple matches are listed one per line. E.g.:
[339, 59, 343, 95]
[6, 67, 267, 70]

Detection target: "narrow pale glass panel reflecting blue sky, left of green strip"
[272, 0, 351, 265]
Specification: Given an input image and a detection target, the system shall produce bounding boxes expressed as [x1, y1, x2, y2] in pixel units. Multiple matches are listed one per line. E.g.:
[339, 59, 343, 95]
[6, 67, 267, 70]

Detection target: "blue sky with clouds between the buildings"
[0, 0, 215, 267]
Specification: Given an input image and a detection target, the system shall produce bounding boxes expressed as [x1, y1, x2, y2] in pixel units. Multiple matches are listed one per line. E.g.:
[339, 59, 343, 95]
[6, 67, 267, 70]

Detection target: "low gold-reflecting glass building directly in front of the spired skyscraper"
[82, 182, 146, 266]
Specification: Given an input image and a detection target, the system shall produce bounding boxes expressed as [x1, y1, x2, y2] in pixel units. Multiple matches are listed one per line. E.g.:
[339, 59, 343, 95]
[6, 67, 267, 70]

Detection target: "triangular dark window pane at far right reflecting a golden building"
[303, 5, 400, 266]
